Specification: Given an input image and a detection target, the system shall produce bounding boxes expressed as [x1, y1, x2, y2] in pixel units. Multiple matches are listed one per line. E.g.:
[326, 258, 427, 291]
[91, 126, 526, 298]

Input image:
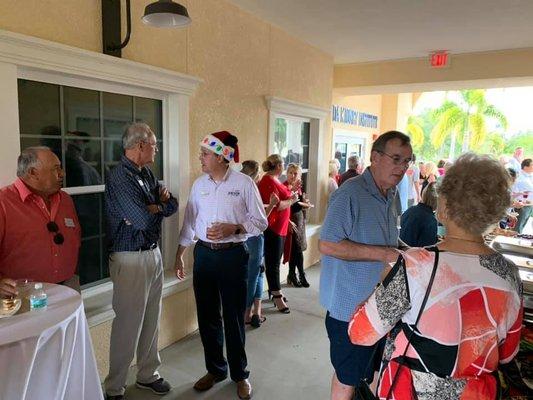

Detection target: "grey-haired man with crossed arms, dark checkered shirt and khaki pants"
[104, 123, 178, 400]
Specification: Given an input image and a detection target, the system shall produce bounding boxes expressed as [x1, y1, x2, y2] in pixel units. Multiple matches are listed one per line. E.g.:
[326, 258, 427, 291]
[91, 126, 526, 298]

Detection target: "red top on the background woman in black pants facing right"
[258, 174, 291, 236]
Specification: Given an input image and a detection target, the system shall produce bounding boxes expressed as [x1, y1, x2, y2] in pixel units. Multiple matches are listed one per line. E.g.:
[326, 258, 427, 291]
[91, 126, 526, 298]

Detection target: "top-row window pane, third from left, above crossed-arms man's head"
[103, 93, 133, 138]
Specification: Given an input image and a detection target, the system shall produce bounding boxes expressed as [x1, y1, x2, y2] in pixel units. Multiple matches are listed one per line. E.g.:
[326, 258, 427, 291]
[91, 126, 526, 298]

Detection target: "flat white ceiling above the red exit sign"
[230, 0, 533, 64]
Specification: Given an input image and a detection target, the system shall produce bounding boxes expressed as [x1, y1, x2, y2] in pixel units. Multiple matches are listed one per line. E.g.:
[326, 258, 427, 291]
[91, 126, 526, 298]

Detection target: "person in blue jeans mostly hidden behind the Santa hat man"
[241, 160, 279, 328]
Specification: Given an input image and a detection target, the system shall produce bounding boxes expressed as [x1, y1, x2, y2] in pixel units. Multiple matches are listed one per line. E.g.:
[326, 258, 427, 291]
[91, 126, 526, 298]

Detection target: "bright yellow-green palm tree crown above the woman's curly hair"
[431, 89, 507, 160]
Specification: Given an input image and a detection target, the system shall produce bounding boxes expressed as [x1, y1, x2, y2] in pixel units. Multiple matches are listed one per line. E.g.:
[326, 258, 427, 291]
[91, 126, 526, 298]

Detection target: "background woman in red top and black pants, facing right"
[258, 154, 298, 314]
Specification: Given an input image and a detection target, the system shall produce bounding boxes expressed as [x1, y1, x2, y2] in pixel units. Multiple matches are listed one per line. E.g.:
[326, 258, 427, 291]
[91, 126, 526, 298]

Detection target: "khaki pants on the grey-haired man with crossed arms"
[104, 247, 163, 396]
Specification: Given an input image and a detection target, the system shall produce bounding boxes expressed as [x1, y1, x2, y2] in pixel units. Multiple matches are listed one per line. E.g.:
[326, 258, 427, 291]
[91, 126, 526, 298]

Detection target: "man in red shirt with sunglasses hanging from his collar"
[0, 147, 80, 294]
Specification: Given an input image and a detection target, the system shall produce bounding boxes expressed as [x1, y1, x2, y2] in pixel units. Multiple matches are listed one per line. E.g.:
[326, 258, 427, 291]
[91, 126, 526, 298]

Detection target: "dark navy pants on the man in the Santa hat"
[193, 244, 249, 382]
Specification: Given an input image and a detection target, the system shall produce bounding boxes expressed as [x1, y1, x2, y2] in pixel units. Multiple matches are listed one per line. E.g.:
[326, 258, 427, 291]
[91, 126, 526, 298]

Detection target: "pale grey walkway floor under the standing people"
[120, 265, 332, 400]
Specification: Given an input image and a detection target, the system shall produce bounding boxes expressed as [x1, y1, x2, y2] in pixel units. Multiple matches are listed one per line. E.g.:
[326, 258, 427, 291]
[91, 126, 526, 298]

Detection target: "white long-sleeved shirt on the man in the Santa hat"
[179, 168, 268, 247]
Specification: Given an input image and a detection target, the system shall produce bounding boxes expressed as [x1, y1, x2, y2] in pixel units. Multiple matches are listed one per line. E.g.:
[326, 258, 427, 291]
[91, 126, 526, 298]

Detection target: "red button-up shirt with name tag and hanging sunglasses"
[0, 179, 81, 283]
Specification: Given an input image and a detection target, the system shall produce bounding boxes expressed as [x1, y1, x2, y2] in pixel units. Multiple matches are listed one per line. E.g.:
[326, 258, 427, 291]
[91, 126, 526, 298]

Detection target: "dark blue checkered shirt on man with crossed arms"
[105, 156, 178, 252]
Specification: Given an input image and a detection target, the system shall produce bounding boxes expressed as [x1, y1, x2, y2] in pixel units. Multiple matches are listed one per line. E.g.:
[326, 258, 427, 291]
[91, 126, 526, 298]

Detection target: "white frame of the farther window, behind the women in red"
[265, 96, 330, 224]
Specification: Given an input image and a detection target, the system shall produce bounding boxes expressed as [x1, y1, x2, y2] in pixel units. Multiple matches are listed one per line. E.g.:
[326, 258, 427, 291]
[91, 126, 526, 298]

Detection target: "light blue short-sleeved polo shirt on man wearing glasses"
[320, 168, 399, 322]
